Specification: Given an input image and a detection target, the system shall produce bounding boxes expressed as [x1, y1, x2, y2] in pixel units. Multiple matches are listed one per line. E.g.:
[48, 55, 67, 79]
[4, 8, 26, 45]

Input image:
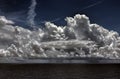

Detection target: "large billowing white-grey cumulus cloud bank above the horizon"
[0, 14, 120, 58]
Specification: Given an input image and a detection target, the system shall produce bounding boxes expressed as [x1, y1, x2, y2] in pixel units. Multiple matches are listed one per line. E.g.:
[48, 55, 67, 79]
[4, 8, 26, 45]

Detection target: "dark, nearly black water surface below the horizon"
[0, 64, 120, 79]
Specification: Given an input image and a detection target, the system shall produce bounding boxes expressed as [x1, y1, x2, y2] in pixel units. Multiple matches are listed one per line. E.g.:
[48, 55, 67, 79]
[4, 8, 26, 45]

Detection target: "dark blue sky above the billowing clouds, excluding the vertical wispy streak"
[0, 0, 120, 33]
